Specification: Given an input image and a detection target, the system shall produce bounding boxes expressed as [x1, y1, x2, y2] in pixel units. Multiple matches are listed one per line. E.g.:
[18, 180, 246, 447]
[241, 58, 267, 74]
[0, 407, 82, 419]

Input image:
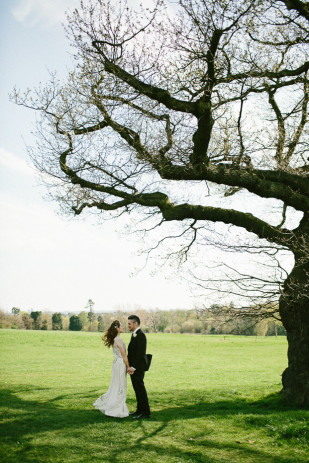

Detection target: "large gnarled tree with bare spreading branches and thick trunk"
[16, 0, 309, 404]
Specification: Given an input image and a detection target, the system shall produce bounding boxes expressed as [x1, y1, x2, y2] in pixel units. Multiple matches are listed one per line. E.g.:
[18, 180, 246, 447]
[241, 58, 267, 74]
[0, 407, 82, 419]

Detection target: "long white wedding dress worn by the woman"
[93, 336, 129, 418]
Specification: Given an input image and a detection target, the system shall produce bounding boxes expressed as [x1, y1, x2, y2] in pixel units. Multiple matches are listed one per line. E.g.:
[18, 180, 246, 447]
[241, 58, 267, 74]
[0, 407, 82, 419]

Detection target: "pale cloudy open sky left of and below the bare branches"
[0, 0, 194, 311]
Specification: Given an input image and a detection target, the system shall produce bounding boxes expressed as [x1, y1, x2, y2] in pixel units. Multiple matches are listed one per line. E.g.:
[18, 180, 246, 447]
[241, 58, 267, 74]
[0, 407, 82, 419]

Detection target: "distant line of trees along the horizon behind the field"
[0, 300, 286, 336]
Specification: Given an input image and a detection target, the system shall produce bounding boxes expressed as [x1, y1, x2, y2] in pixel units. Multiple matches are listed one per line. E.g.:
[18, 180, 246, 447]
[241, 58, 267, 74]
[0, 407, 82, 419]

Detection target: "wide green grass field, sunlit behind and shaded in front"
[0, 330, 309, 463]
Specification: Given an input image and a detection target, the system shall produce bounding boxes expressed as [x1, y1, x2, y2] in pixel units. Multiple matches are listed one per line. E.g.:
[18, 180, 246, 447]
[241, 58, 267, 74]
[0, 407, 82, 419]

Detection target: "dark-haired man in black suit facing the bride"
[128, 315, 150, 420]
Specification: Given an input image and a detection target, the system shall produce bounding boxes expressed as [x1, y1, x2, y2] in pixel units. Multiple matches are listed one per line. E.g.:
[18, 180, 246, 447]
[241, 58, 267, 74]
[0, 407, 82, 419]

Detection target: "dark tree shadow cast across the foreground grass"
[0, 387, 309, 463]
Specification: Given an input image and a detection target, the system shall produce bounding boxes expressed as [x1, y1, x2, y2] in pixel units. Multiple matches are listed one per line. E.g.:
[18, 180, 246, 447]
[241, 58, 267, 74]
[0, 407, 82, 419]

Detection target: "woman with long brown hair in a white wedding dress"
[93, 320, 130, 418]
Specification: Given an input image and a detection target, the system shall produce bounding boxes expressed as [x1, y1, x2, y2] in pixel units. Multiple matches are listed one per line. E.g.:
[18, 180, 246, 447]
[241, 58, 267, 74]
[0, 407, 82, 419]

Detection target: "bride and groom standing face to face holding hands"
[93, 315, 151, 420]
